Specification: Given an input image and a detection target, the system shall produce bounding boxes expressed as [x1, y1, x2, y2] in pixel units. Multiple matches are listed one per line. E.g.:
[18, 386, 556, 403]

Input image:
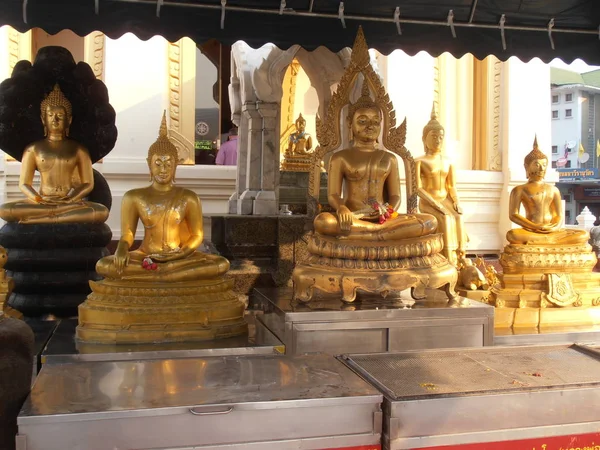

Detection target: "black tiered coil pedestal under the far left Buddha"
[0, 223, 112, 317]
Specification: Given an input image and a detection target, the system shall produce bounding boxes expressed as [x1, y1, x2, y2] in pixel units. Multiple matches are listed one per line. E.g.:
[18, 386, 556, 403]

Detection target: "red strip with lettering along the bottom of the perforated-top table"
[418, 433, 600, 450]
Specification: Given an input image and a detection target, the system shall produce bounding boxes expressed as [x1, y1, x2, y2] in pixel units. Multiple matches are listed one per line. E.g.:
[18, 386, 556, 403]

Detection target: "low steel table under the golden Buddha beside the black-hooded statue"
[41, 316, 285, 364]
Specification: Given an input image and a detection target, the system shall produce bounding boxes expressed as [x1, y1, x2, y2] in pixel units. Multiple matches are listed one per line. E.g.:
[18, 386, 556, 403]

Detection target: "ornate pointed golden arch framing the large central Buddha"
[307, 27, 418, 217]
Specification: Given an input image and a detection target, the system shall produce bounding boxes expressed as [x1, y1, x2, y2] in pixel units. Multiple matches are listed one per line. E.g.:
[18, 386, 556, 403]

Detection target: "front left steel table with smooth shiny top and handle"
[17, 355, 382, 450]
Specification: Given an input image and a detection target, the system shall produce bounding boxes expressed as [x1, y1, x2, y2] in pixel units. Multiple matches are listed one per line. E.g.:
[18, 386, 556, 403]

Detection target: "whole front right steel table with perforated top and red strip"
[340, 345, 600, 450]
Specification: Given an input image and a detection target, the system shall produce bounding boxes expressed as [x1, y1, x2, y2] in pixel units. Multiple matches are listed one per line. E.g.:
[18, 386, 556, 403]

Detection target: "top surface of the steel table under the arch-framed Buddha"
[251, 288, 494, 322]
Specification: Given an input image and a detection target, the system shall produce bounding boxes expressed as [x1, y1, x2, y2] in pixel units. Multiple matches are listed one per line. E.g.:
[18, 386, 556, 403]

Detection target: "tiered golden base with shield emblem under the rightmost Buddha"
[489, 244, 600, 328]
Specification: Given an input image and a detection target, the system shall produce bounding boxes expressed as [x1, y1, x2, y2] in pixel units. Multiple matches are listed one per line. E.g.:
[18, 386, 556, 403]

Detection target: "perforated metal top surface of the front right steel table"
[346, 346, 600, 400]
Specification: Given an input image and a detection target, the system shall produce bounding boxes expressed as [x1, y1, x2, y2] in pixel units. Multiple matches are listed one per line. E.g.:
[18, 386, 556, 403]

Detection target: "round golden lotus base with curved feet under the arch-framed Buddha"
[292, 233, 458, 303]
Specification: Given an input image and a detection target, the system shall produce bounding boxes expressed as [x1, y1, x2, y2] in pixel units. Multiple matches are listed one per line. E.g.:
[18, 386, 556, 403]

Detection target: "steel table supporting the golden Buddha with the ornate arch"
[251, 288, 494, 355]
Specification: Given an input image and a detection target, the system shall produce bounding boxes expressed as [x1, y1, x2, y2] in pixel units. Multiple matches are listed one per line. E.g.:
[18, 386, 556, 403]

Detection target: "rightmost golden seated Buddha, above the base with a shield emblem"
[506, 137, 589, 245]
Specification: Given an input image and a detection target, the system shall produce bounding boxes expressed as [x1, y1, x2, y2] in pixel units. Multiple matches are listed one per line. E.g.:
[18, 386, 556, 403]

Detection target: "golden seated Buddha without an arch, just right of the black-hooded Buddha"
[96, 112, 229, 282]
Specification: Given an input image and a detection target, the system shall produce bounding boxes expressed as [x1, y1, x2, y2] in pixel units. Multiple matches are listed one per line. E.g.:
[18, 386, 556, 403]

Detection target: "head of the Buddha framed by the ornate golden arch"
[347, 80, 381, 143]
